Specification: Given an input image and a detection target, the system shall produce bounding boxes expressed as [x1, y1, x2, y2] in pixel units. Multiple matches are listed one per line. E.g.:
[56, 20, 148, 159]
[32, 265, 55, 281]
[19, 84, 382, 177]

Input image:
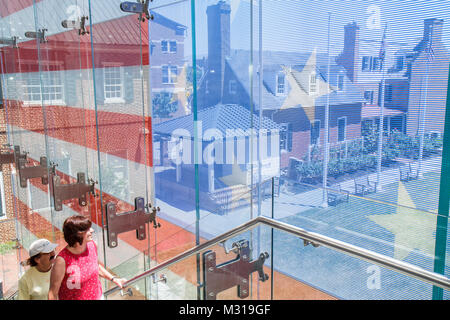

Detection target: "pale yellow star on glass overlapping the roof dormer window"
[280, 49, 333, 122]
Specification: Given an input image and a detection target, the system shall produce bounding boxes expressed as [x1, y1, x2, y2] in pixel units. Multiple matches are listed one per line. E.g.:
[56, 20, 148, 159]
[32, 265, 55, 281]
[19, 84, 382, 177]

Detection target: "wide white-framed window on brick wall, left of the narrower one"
[23, 71, 66, 106]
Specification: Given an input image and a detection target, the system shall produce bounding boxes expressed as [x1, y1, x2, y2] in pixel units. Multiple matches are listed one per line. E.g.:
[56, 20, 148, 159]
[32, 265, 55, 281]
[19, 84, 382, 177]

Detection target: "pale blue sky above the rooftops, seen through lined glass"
[155, 0, 450, 56]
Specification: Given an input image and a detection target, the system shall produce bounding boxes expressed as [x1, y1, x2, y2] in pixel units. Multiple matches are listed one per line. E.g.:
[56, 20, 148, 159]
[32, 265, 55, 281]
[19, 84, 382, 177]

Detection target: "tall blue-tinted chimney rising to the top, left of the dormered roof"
[206, 0, 231, 104]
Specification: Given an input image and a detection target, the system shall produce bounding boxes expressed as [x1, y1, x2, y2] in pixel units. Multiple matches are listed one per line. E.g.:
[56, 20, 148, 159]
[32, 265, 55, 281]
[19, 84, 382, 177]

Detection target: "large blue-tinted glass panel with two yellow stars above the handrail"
[264, 1, 449, 298]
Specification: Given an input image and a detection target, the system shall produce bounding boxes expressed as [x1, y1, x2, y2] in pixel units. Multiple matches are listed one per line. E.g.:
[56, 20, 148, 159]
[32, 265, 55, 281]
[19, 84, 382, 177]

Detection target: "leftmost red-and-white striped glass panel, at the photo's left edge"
[0, 1, 58, 296]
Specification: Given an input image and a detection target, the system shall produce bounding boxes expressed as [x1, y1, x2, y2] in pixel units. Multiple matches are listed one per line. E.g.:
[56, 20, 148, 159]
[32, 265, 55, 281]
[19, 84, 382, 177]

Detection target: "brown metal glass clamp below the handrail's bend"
[203, 240, 269, 300]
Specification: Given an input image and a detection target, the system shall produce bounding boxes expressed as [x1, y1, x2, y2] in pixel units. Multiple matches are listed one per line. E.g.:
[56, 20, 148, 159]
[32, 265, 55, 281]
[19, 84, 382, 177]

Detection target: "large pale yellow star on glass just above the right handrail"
[369, 182, 437, 260]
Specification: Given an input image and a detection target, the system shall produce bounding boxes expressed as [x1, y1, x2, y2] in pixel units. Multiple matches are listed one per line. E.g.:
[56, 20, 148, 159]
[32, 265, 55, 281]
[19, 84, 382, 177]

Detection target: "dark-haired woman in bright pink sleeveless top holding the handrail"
[48, 216, 126, 300]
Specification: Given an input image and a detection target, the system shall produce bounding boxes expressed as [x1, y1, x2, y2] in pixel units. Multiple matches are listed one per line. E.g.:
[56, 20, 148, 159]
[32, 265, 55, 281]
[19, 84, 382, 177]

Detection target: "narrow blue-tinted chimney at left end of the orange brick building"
[336, 21, 359, 82]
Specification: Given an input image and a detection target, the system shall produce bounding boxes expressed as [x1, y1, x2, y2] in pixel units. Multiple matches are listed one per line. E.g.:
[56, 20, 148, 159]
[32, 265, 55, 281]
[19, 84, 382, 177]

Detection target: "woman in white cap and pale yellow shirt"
[18, 239, 58, 300]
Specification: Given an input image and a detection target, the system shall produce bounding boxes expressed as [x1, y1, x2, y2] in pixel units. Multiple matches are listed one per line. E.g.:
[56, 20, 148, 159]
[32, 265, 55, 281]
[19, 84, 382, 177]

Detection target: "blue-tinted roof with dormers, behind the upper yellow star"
[226, 50, 365, 110]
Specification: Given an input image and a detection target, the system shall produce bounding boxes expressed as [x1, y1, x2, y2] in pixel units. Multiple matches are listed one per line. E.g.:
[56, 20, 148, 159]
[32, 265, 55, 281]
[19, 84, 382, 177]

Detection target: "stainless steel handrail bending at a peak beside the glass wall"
[104, 216, 450, 296]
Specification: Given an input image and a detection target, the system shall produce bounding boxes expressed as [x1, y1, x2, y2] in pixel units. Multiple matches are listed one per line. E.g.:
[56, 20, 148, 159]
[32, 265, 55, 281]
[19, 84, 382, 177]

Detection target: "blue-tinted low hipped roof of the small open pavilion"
[153, 104, 280, 137]
